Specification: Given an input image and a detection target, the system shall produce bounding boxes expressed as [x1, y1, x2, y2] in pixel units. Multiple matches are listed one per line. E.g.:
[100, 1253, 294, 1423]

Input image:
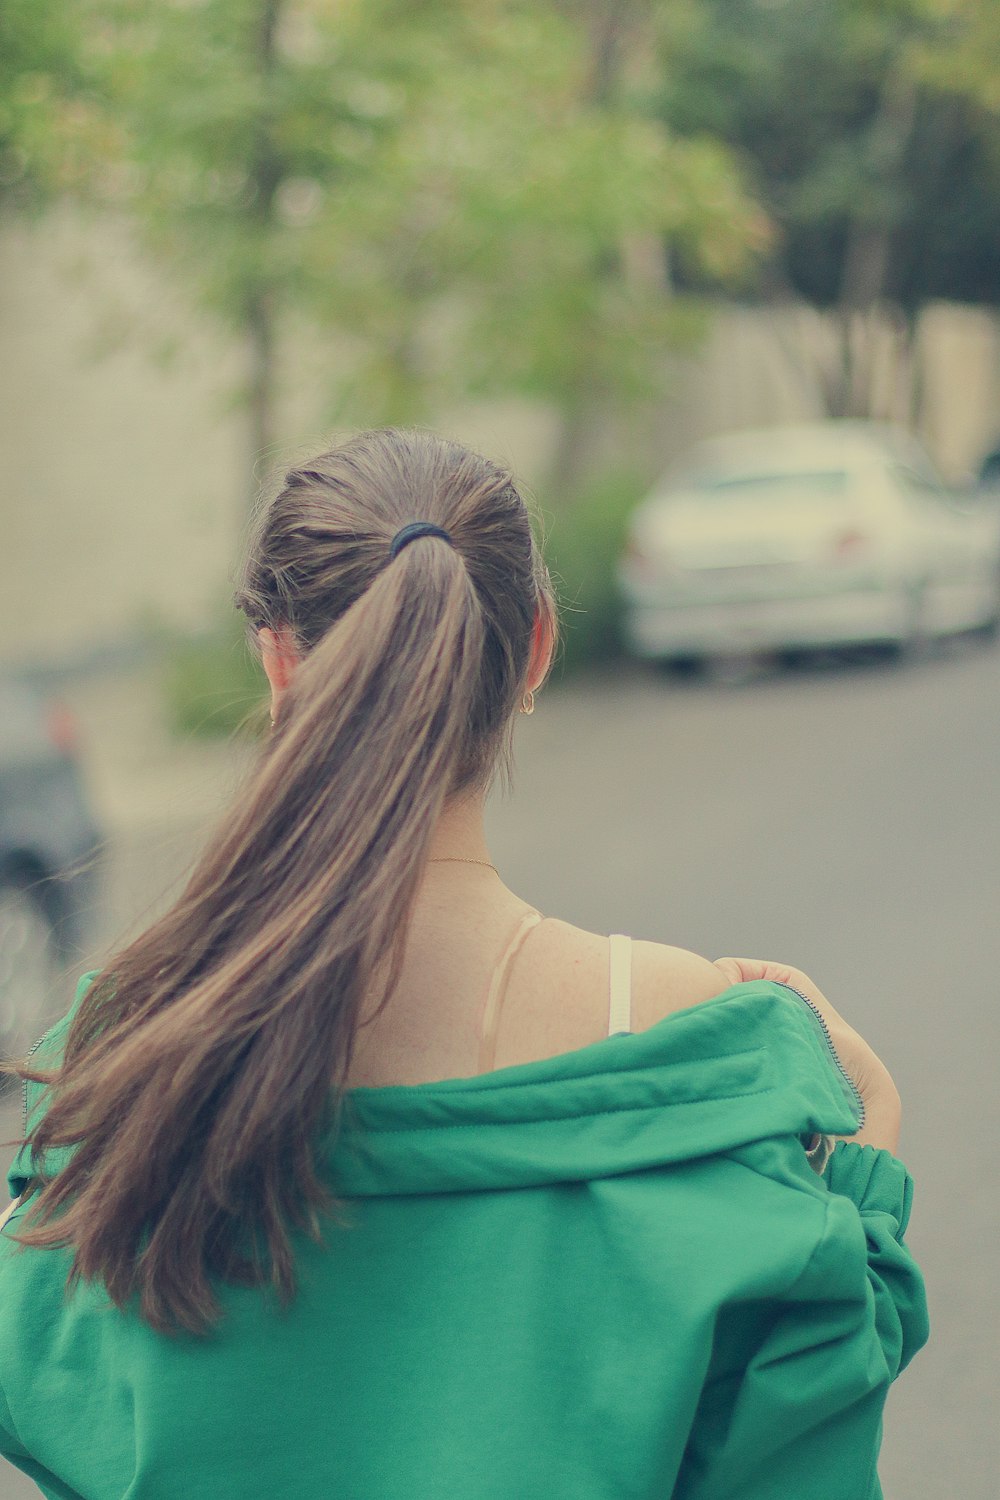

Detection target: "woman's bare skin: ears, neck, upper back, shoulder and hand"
[259, 642, 900, 1151]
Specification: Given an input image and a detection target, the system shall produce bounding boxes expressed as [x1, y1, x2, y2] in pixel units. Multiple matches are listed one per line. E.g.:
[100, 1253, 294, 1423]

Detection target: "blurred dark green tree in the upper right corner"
[661, 0, 1000, 422]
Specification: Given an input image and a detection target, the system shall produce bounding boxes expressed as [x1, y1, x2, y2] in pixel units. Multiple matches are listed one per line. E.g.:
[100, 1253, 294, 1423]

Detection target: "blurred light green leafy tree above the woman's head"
[78, 0, 763, 498]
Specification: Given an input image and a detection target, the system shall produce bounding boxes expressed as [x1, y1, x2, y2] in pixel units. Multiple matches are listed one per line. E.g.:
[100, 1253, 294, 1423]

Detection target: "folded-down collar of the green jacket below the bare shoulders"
[9, 975, 859, 1197]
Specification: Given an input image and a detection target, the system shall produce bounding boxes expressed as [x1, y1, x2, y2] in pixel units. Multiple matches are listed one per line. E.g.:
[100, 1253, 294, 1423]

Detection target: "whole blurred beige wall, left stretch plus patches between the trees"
[0, 218, 1000, 660]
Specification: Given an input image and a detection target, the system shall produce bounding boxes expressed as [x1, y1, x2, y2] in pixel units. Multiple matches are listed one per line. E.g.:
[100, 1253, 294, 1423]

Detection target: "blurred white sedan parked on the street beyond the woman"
[619, 422, 1000, 662]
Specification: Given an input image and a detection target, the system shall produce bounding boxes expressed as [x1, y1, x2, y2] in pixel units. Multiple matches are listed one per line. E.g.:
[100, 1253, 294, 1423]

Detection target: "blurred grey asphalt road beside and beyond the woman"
[0, 644, 1000, 1500]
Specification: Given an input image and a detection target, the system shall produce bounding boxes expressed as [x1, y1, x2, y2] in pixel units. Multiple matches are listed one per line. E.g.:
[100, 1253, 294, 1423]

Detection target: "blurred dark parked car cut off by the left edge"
[0, 675, 100, 1056]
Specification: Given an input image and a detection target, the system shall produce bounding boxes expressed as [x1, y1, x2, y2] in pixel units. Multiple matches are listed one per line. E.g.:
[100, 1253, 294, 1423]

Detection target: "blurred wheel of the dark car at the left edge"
[0, 876, 63, 1059]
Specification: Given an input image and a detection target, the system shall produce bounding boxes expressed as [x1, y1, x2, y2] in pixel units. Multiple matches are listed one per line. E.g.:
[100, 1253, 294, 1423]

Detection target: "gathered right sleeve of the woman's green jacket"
[675, 1143, 928, 1500]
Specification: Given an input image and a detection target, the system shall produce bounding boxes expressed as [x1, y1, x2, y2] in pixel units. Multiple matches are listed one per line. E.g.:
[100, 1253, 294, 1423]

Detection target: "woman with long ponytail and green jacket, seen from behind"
[0, 431, 925, 1500]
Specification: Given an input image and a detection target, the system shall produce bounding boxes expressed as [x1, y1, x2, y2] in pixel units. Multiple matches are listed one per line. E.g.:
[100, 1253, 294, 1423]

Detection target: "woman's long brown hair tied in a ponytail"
[3, 429, 555, 1334]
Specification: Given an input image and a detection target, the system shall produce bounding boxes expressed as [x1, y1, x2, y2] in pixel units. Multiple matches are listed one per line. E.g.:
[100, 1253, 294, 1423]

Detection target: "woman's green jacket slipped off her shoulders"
[0, 981, 927, 1500]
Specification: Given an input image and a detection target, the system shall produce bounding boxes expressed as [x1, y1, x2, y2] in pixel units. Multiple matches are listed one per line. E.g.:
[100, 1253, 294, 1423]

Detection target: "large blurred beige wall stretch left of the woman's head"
[0, 221, 248, 657]
